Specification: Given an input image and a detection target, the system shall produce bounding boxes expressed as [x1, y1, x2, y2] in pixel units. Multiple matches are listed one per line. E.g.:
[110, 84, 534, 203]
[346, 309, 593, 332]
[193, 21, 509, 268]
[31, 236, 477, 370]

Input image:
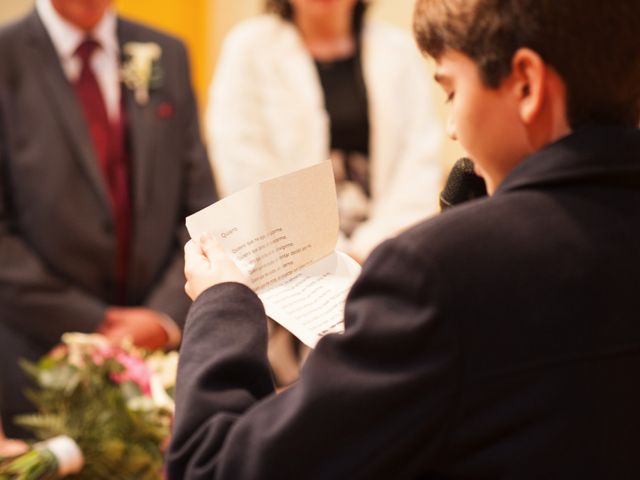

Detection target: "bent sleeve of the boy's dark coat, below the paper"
[168, 238, 459, 480]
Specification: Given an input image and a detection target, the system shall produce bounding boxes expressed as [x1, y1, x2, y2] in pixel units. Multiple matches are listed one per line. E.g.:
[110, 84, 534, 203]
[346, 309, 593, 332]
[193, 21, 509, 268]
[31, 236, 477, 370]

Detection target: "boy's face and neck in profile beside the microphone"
[434, 49, 532, 193]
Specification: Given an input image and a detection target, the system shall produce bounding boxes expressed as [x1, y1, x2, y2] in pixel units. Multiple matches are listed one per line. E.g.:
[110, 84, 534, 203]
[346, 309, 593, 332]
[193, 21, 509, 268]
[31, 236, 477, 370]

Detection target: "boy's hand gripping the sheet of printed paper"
[184, 235, 249, 300]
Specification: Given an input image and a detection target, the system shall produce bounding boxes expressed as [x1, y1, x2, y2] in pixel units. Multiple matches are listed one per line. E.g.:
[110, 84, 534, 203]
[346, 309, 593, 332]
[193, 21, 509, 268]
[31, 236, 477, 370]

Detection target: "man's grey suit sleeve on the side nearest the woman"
[145, 43, 218, 326]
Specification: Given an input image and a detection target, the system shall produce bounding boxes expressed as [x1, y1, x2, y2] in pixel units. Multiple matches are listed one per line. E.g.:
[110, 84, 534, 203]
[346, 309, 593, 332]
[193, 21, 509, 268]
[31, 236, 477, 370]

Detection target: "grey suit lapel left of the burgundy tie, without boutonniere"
[27, 12, 111, 217]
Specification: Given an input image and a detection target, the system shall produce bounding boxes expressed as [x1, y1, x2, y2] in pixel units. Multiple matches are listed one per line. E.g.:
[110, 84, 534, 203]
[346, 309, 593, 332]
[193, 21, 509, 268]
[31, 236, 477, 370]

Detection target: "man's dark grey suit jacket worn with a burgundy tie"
[0, 12, 215, 436]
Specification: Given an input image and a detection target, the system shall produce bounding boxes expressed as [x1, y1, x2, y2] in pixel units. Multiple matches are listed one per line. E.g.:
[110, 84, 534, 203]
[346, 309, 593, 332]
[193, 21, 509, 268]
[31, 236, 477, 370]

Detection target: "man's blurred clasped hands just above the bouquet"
[98, 307, 169, 350]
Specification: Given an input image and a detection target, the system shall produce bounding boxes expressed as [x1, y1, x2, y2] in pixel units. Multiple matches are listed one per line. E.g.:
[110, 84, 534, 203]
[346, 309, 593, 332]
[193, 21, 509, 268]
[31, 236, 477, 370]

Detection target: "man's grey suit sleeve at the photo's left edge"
[0, 92, 106, 348]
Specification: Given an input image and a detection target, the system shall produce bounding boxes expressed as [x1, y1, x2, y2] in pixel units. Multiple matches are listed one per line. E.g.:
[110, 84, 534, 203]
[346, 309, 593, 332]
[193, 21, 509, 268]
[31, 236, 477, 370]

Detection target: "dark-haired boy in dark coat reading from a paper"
[168, 0, 640, 480]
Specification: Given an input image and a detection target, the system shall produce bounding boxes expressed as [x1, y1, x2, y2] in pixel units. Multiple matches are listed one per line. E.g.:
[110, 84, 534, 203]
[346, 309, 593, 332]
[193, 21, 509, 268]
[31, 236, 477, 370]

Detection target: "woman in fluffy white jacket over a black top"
[207, 0, 442, 261]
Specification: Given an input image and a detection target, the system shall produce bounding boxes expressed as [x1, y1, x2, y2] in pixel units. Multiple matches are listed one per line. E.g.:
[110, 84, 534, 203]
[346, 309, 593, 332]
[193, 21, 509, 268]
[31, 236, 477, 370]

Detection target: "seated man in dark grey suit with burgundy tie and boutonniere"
[0, 0, 215, 434]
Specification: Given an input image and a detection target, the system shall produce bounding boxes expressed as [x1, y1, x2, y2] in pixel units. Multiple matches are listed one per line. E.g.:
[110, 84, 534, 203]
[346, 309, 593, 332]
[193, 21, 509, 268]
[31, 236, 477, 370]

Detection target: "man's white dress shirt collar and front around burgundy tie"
[36, 0, 120, 121]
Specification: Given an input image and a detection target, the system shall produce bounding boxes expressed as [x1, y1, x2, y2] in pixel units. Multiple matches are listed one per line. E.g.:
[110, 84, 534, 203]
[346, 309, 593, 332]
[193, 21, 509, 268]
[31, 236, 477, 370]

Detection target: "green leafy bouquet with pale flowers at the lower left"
[0, 334, 171, 480]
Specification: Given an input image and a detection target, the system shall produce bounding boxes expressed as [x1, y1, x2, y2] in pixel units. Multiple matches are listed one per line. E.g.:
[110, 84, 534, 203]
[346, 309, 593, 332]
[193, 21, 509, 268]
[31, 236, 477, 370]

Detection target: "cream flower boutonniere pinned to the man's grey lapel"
[120, 42, 162, 105]
